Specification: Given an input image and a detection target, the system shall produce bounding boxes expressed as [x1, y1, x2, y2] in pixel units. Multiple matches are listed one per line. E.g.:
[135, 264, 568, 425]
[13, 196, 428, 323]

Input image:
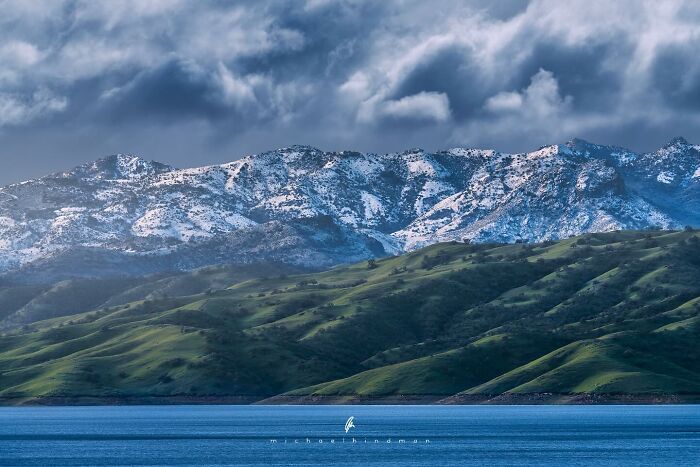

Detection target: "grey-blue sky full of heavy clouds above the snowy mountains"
[0, 0, 700, 183]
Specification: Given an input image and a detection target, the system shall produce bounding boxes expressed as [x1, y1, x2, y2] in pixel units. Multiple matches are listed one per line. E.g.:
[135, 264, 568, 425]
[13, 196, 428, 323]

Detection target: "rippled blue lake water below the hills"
[0, 405, 700, 467]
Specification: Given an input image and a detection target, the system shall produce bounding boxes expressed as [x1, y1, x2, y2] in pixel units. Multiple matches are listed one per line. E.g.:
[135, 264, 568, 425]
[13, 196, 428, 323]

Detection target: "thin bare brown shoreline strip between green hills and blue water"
[0, 393, 700, 407]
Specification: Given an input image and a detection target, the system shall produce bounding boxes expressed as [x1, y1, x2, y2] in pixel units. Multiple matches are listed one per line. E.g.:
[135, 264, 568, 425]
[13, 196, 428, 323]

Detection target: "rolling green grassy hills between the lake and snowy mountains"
[0, 231, 700, 402]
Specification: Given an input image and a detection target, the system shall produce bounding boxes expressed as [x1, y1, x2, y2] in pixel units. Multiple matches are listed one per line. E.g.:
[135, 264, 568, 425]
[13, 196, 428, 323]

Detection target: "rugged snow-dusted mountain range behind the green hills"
[0, 138, 700, 281]
